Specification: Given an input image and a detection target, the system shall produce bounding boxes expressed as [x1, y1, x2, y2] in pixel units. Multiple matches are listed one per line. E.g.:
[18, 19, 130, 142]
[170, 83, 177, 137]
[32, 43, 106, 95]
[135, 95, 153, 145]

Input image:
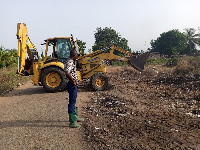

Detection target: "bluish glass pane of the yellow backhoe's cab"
[57, 39, 72, 63]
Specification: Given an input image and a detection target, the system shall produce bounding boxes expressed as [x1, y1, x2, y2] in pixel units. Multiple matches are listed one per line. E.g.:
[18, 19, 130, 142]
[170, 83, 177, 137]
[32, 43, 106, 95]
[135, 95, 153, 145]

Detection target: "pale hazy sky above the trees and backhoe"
[0, 0, 200, 53]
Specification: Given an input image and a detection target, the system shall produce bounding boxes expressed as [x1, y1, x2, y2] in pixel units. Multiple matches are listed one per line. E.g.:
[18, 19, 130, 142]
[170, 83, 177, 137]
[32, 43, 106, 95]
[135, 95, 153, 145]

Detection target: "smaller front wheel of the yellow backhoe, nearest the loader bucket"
[90, 72, 108, 91]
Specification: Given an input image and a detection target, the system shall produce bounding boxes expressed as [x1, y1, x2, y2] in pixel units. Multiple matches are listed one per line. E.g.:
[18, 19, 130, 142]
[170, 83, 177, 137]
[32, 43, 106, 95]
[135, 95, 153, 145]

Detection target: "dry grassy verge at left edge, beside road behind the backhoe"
[0, 65, 31, 95]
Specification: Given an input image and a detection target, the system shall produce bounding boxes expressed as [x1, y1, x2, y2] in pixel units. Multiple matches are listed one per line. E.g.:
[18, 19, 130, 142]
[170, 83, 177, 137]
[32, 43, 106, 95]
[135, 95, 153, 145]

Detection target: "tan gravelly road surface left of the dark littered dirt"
[0, 82, 87, 150]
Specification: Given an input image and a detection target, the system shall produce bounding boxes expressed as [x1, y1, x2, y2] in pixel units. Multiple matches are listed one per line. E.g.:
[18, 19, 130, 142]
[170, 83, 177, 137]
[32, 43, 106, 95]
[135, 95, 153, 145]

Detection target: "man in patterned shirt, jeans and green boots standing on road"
[64, 50, 84, 128]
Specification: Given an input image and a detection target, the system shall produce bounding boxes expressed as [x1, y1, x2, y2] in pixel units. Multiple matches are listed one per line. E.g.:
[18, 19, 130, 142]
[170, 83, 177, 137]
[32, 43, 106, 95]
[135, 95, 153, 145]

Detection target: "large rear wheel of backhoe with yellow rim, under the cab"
[41, 67, 66, 93]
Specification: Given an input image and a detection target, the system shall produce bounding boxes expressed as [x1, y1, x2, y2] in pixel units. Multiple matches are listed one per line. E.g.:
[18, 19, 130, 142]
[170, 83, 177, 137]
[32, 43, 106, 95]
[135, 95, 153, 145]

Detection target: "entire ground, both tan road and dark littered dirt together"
[0, 67, 200, 150]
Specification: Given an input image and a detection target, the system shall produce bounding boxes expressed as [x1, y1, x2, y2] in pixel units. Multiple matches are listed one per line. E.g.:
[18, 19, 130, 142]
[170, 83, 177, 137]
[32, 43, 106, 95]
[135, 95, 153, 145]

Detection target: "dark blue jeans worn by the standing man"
[66, 82, 78, 113]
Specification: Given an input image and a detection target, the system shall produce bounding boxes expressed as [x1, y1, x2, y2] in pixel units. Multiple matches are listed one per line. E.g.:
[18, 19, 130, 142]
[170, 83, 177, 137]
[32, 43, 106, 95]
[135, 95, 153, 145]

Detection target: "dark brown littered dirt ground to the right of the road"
[81, 67, 200, 150]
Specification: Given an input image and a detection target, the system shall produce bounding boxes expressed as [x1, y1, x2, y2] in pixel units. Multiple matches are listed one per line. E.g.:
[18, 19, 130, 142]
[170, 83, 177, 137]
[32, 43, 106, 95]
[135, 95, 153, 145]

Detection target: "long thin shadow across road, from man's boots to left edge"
[0, 120, 69, 129]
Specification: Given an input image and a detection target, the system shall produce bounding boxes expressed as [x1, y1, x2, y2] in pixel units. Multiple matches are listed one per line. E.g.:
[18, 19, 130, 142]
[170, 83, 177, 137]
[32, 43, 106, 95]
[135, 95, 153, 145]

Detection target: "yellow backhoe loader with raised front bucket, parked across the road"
[17, 23, 149, 92]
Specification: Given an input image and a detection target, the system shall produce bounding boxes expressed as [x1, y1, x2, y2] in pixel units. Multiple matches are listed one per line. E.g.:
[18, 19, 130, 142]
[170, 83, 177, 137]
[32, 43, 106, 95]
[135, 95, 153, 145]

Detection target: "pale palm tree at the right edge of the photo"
[184, 28, 200, 54]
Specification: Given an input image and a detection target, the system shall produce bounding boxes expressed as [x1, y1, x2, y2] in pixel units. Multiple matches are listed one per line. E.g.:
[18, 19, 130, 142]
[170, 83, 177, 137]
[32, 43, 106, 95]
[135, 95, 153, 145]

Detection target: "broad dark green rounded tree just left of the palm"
[150, 29, 187, 56]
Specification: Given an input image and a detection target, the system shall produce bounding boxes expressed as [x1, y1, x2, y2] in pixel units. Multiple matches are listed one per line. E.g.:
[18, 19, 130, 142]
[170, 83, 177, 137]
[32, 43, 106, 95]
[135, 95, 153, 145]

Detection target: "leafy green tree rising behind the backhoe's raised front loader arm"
[92, 27, 131, 52]
